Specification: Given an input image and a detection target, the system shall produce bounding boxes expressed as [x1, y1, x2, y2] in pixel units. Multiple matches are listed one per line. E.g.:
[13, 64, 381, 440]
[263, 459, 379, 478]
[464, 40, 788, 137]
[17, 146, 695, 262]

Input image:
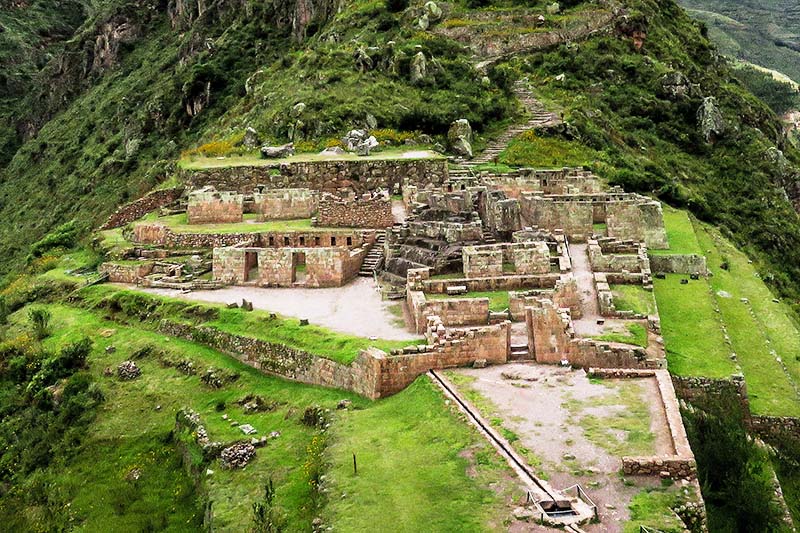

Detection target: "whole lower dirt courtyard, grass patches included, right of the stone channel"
[448, 364, 673, 532]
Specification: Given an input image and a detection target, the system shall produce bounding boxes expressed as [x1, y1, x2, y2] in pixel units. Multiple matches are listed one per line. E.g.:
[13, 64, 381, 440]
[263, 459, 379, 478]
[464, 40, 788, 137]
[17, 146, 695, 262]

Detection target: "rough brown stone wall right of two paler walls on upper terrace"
[317, 194, 394, 229]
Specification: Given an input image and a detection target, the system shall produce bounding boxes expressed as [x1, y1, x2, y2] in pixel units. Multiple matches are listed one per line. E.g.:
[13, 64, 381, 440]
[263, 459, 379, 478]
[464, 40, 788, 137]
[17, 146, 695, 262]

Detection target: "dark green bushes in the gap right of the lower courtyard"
[683, 402, 784, 532]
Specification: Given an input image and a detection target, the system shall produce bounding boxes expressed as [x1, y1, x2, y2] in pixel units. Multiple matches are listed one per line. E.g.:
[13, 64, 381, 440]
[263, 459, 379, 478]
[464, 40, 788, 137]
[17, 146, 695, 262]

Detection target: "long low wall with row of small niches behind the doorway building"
[131, 223, 375, 248]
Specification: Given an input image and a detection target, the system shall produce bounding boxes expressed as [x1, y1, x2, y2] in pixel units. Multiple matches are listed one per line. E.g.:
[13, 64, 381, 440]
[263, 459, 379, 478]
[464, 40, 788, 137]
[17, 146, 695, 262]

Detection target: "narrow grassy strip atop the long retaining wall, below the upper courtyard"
[80, 285, 425, 364]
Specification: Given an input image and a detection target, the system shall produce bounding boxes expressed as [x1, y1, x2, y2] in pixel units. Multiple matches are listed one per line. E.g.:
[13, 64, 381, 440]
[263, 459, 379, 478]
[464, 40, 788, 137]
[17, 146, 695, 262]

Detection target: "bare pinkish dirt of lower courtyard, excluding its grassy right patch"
[455, 363, 673, 533]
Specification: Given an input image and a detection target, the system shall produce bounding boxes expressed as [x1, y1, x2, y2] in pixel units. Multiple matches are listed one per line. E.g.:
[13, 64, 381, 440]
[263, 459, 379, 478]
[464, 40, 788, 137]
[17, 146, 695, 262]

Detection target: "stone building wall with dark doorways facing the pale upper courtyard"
[213, 246, 368, 288]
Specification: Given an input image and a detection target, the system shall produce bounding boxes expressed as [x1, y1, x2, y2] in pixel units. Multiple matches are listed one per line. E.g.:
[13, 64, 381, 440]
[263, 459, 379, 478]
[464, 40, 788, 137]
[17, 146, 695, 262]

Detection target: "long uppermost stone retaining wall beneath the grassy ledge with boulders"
[181, 158, 448, 193]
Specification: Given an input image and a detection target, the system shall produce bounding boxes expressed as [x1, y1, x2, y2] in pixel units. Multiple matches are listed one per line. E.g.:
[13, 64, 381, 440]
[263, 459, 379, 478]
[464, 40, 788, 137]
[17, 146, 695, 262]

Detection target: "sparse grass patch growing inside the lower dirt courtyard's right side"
[564, 380, 655, 457]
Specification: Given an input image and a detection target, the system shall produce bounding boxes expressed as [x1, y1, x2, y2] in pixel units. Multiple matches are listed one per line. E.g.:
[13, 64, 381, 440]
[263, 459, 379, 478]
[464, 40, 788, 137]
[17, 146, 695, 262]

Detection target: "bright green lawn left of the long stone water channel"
[323, 376, 509, 532]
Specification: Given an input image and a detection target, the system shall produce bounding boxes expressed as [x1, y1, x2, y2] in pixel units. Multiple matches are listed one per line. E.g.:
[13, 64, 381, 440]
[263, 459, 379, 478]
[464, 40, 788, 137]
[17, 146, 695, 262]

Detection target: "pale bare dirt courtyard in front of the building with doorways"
[138, 277, 420, 340]
